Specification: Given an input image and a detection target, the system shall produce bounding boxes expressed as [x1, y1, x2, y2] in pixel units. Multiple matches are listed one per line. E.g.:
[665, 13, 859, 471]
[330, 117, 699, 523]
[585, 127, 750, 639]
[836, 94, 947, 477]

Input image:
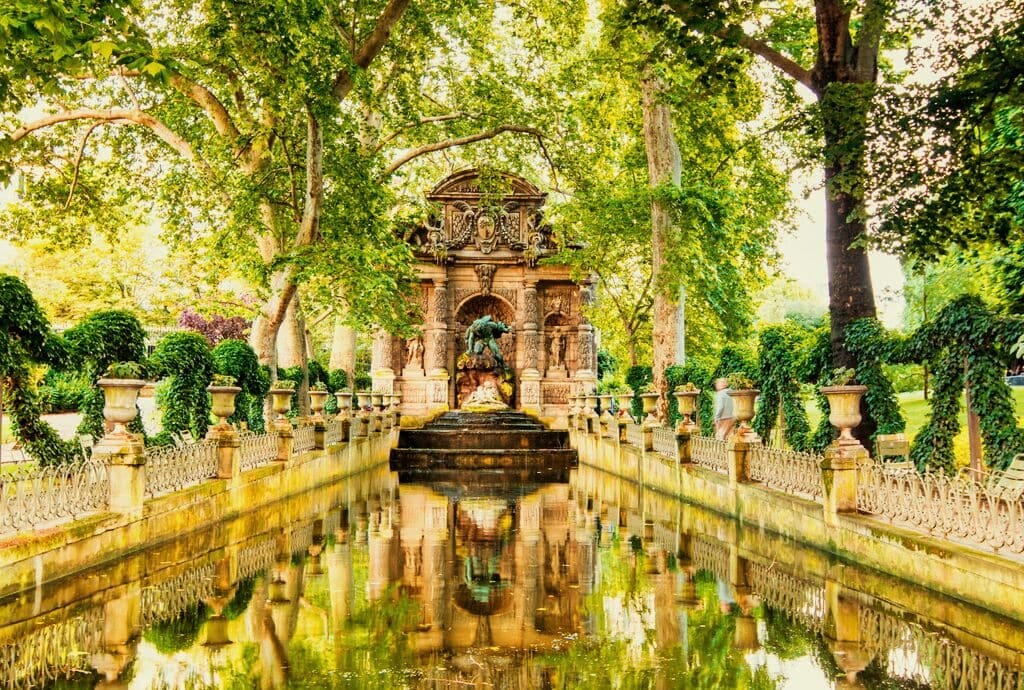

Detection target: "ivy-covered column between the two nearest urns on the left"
[148, 332, 214, 444]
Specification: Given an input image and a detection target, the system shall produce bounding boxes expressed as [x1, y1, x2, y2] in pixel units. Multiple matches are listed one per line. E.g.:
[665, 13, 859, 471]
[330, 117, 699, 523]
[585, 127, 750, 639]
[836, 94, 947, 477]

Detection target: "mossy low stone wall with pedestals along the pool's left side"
[0, 424, 398, 597]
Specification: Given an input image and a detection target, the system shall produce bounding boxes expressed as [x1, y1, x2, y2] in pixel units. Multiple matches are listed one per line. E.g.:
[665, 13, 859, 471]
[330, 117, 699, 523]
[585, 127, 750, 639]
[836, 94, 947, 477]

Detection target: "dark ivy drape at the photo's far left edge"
[0, 274, 79, 465]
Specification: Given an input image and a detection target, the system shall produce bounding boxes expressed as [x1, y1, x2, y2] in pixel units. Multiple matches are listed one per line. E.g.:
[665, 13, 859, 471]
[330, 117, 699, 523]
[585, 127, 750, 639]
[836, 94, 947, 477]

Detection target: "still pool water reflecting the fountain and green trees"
[0, 469, 1024, 690]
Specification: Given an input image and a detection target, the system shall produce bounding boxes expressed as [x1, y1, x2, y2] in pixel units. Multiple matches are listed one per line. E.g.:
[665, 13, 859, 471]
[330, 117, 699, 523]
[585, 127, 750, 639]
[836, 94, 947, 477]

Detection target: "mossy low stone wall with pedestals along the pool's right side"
[570, 421, 1024, 621]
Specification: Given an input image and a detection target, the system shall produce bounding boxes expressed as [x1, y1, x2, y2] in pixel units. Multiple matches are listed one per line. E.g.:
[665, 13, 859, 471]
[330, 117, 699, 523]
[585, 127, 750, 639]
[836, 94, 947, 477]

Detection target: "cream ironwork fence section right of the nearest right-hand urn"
[857, 463, 1024, 554]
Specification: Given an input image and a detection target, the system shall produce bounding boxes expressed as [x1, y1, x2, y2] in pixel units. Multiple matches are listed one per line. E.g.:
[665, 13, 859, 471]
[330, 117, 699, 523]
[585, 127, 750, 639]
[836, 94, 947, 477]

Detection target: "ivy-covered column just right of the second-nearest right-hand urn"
[754, 325, 811, 450]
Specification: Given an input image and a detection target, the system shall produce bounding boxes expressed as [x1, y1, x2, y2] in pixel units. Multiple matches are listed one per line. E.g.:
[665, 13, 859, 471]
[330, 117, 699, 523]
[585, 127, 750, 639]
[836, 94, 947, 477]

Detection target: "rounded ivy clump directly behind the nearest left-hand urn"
[63, 310, 145, 438]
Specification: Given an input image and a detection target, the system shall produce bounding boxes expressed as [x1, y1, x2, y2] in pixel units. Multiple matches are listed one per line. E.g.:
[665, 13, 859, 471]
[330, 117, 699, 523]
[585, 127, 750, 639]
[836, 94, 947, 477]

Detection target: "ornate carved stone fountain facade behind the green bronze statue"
[372, 170, 597, 424]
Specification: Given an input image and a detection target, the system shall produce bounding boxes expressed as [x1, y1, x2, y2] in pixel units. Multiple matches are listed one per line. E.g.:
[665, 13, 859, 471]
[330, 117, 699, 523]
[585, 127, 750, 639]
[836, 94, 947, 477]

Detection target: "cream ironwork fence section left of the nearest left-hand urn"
[0, 460, 111, 534]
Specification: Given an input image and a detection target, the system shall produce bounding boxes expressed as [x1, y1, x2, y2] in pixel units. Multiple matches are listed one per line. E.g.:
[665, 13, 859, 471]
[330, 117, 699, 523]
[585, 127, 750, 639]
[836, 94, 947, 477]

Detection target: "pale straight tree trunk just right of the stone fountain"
[640, 68, 682, 413]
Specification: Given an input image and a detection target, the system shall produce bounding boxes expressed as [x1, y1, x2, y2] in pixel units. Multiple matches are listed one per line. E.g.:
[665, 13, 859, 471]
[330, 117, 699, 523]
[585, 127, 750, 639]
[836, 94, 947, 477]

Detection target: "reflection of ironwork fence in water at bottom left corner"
[0, 606, 103, 690]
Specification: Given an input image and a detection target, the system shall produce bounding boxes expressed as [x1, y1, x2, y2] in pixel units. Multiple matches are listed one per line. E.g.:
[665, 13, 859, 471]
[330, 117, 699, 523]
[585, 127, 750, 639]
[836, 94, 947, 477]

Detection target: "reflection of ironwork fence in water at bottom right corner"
[858, 606, 1024, 690]
